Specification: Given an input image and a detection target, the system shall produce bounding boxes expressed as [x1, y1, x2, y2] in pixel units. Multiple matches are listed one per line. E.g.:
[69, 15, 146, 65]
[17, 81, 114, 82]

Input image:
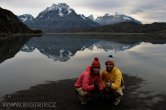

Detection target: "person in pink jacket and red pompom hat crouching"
[75, 57, 103, 104]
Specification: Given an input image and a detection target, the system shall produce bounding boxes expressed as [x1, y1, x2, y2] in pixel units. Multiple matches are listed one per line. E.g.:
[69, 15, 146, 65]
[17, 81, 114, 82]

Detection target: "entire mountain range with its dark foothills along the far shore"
[0, 3, 166, 36]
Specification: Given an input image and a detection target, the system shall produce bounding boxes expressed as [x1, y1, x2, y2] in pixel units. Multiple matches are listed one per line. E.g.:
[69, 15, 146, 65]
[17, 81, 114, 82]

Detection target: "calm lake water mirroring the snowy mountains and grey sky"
[0, 35, 166, 96]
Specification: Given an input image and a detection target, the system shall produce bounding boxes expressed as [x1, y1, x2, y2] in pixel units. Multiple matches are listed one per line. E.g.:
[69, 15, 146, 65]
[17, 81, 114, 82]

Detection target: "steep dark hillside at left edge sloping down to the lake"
[0, 7, 41, 36]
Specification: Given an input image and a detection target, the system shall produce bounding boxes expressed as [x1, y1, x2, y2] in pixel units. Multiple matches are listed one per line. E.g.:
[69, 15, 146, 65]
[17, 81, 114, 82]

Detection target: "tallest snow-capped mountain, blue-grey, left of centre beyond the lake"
[18, 3, 99, 32]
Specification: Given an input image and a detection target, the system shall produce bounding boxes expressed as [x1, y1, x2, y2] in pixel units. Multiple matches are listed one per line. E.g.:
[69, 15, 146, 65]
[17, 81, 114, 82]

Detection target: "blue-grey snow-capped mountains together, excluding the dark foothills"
[18, 3, 142, 32]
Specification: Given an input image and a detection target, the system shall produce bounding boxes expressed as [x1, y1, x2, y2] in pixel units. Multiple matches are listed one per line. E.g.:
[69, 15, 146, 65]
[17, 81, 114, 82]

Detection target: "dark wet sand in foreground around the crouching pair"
[0, 74, 166, 110]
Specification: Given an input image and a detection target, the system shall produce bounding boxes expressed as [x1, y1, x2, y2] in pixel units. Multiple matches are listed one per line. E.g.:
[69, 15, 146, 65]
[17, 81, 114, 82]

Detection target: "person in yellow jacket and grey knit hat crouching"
[101, 55, 124, 105]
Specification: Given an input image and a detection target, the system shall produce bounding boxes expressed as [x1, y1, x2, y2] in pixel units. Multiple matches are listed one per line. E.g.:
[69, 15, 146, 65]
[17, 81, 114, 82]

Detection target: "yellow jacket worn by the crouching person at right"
[101, 66, 123, 90]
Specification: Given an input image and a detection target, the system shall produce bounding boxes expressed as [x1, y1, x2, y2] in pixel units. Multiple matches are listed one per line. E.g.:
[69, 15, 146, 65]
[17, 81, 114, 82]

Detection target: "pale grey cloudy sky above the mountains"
[0, 0, 166, 23]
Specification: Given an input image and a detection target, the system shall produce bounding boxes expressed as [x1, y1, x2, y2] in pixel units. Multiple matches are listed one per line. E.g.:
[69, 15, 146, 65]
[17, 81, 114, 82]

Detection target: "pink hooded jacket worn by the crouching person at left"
[75, 66, 103, 91]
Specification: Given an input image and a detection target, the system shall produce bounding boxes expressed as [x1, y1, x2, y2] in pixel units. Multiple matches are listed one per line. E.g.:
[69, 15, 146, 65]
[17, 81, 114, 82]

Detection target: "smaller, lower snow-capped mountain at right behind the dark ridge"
[94, 12, 142, 25]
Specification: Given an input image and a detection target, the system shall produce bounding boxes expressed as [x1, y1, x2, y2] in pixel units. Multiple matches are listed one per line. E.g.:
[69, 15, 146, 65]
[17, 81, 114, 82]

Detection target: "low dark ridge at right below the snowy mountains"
[85, 22, 166, 33]
